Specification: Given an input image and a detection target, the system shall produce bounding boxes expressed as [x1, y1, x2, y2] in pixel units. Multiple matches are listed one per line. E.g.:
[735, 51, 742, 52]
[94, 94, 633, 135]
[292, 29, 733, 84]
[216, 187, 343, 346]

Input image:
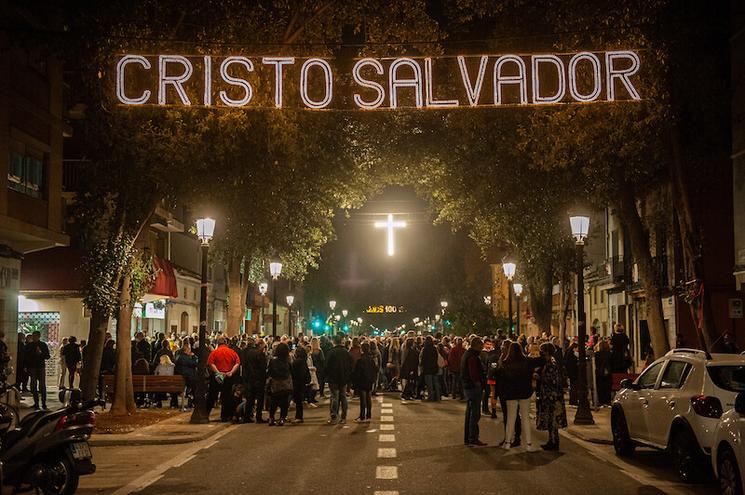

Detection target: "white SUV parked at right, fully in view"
[611, 349, 745, 482]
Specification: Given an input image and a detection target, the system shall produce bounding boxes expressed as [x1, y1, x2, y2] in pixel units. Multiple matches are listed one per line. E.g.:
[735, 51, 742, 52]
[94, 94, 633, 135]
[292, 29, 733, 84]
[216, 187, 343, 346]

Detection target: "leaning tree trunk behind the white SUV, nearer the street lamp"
[616, 184, 670, 358]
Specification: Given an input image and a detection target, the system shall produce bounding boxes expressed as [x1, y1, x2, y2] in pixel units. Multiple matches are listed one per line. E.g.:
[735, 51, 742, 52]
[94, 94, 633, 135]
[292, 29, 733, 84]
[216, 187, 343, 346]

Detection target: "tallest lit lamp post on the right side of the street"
[569, 215, 595, 425]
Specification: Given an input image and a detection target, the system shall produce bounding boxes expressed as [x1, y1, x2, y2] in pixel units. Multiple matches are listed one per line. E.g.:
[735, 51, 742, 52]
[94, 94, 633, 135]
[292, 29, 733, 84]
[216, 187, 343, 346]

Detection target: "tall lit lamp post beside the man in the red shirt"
[189, 218, 215, 424]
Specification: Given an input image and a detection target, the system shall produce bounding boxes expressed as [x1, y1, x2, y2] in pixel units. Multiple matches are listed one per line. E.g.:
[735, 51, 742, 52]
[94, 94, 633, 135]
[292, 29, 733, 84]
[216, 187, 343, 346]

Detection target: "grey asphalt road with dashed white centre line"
[79, 395, 716, 495]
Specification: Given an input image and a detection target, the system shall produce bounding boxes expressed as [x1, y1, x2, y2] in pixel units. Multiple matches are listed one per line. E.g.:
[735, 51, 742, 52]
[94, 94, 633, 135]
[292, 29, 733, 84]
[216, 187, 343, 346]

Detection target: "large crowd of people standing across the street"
[13, 325, 631, 450]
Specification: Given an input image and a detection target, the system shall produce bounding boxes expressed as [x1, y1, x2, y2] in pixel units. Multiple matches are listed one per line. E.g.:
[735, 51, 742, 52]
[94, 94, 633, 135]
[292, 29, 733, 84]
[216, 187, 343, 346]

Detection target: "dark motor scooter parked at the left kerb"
[0, 390, 102, 495]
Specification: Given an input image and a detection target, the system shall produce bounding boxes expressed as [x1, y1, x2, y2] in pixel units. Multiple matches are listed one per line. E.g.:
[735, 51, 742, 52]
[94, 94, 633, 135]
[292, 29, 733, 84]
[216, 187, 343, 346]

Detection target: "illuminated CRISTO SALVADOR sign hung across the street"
[116, 50, 641, 110]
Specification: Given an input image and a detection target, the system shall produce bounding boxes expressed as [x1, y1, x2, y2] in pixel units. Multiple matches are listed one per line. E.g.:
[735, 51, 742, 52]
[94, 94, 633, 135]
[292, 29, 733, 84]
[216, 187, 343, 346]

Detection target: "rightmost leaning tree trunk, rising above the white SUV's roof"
[670, 127, 719, 352]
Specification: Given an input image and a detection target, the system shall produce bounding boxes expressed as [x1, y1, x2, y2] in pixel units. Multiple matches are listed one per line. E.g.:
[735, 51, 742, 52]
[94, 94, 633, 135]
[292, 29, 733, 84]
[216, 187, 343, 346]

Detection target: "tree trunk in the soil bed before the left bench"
[111, 273, 137, 416]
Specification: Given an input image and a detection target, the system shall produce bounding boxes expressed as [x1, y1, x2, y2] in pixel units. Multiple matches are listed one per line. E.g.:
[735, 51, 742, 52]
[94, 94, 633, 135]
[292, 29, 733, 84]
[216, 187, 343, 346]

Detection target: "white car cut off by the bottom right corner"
[711, 392, 745, 495]
